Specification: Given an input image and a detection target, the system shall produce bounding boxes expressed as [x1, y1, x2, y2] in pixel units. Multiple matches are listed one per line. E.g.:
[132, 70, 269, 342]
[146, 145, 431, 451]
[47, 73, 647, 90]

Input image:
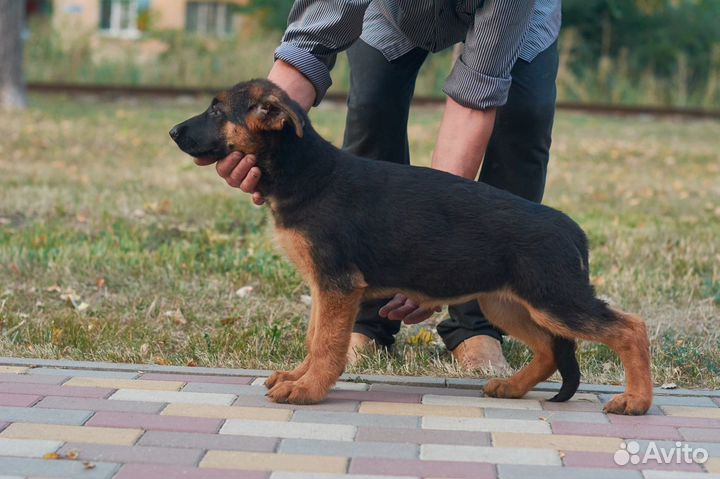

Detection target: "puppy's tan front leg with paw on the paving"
[267, 288, 363, 404]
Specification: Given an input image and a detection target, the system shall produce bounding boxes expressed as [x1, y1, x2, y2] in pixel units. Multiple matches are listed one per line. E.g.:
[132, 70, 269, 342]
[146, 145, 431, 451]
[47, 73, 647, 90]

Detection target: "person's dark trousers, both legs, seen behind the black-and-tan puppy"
[343, 40, 558, 350]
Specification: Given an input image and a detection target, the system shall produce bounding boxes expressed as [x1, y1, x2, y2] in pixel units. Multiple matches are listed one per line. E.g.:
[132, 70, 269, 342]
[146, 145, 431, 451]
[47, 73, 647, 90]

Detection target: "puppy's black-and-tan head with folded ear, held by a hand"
[170, 80, 305, 160]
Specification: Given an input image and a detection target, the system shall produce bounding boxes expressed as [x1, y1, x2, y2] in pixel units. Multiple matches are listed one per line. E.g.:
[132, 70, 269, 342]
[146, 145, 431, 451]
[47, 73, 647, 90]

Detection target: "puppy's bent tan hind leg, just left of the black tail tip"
[479, 294, 557, 398]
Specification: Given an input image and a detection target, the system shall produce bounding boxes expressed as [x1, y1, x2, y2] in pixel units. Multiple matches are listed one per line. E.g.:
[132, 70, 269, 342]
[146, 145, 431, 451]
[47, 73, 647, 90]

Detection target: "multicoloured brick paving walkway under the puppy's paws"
[0, 358, 720, 479]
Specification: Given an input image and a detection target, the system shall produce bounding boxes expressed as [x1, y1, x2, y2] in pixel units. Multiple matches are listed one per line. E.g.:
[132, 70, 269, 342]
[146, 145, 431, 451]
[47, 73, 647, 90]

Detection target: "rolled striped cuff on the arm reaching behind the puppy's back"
[443, 57, 512, 110]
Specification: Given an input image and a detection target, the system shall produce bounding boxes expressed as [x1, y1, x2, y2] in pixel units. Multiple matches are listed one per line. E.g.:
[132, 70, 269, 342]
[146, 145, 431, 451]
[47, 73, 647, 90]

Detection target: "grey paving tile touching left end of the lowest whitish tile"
[278, 439, 420, 459]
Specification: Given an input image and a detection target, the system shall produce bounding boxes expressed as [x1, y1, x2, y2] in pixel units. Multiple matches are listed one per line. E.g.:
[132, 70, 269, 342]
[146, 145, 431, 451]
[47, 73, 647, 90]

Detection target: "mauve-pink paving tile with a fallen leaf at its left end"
[58, 442, 204, 466]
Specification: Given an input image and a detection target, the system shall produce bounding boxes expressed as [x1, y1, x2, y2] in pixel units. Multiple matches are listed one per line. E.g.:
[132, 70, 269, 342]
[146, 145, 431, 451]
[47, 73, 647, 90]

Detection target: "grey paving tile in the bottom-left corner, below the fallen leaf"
[0, 457, 119, 479]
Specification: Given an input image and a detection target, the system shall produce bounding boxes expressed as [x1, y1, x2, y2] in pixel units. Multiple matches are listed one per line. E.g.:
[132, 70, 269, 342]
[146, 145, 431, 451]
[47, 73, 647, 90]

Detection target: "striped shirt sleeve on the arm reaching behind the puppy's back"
[443, 0, 534, 110]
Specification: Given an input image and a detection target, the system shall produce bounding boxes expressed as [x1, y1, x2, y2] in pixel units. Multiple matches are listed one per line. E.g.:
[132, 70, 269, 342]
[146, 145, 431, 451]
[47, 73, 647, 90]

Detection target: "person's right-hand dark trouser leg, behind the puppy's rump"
[437, 43, 558, 351]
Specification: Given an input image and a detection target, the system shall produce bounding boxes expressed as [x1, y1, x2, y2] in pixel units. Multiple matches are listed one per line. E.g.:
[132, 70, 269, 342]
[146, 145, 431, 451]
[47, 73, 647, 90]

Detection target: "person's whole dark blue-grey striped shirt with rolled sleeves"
[275, 0, 560, 109]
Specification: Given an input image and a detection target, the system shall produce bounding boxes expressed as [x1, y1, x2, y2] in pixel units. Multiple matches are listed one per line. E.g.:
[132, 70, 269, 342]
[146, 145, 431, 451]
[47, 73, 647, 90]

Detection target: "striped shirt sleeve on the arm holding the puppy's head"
[275, 0, 370, 105]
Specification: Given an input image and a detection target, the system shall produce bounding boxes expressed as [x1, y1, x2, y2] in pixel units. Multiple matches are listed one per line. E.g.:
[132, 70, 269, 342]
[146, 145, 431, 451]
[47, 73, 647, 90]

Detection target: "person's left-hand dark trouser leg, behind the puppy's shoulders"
[343, 40, 428, 346]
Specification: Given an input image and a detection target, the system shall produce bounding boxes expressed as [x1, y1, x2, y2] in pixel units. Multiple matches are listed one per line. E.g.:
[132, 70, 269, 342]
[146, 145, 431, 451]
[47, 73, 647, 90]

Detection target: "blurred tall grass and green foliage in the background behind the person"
[25, 0, 720, 109]
